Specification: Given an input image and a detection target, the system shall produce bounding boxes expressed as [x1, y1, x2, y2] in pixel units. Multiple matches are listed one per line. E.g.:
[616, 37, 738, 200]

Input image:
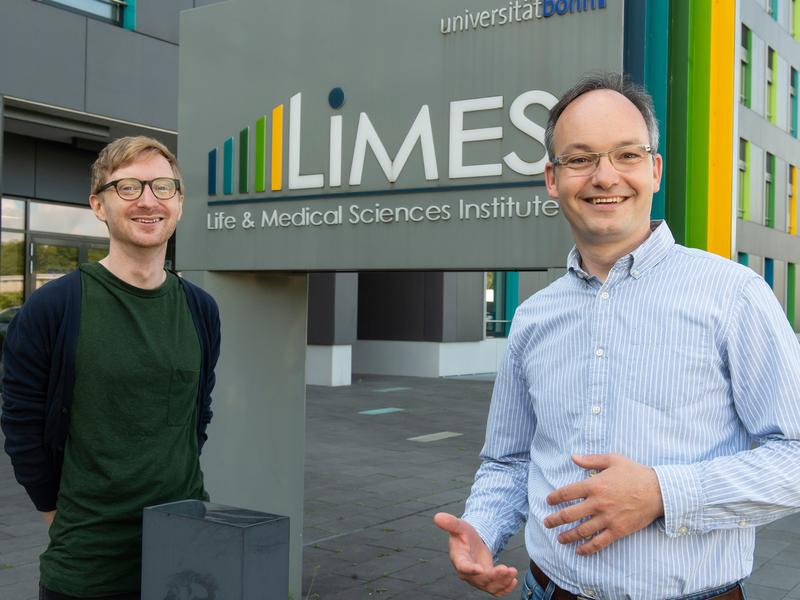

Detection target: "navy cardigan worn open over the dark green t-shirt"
[0, 270, 220, 511]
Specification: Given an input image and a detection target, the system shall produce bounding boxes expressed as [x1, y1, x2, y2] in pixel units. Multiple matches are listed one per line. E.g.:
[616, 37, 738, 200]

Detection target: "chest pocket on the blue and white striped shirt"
[621, 327, 719, 412]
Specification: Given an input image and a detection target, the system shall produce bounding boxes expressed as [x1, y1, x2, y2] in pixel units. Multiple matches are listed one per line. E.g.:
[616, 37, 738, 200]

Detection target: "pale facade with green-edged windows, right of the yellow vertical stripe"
[732, 0, 800, 328]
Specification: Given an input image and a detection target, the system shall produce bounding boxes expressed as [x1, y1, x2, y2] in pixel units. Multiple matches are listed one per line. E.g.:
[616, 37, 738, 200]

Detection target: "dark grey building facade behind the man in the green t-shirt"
[0, 0, 223, 310]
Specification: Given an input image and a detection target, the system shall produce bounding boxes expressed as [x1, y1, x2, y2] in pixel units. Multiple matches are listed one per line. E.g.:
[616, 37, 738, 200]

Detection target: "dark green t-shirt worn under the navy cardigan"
[41, 263, 208, 598]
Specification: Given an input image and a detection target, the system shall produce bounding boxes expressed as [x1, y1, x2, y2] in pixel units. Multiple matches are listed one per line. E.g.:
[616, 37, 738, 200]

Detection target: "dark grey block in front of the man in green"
[142, 500, 289, 600]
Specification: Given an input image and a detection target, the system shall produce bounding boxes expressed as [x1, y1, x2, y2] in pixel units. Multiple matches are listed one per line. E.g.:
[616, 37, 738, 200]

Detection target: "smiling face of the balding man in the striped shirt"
[545, 89, 661, 252]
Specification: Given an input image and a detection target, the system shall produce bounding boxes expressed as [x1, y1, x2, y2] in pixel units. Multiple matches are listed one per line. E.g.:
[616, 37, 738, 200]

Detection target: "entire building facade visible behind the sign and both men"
[0, 0, 800, 385]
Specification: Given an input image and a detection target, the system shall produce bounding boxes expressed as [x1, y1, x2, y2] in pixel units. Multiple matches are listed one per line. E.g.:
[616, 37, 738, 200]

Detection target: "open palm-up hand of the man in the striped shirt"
[433, 513, 517, 596]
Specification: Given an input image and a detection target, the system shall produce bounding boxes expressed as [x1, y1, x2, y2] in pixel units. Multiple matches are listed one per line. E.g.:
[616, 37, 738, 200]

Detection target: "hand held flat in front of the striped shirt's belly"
[544, 454, 664, 556]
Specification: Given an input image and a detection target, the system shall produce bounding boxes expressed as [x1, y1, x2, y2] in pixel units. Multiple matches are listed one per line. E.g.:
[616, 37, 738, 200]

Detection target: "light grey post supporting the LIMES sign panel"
[183, 271, 308, 598]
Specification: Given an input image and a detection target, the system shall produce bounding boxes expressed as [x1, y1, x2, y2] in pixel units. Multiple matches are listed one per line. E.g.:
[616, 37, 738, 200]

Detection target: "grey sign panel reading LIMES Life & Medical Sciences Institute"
[177, 0, 623, 270]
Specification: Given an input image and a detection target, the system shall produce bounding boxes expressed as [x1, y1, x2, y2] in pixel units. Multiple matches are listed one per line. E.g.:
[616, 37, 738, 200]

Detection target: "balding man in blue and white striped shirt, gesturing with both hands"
[435, 74, 800, 600]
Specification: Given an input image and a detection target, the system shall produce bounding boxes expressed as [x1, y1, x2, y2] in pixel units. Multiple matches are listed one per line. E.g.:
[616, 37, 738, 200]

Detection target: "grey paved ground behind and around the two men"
[0, 376, 800, 600]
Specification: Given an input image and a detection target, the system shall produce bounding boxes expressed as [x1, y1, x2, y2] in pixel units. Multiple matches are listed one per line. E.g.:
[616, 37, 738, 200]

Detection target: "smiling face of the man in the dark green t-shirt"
[89, 151, 183, 251]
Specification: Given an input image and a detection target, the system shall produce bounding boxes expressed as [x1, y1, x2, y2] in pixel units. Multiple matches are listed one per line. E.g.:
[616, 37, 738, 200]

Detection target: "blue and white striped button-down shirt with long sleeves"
[464, 223, 800, 600]
